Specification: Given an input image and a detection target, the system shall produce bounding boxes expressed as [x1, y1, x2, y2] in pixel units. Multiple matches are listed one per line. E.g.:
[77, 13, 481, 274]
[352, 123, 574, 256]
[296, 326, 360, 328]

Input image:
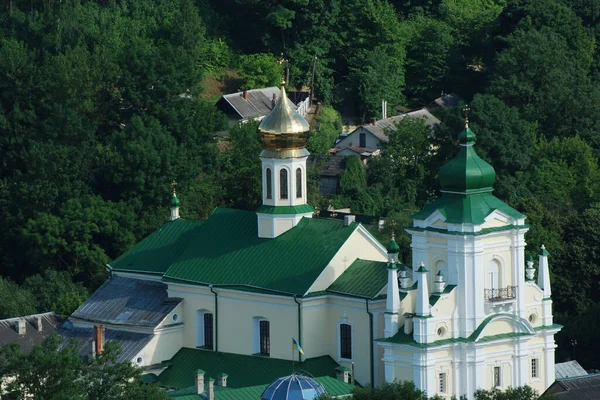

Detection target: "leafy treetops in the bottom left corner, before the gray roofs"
[0, 335, 166, 400]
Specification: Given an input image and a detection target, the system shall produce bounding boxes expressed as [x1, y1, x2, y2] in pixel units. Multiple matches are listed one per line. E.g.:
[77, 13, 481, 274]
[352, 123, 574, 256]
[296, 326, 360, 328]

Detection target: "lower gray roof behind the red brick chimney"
[60, 328, 153, 362]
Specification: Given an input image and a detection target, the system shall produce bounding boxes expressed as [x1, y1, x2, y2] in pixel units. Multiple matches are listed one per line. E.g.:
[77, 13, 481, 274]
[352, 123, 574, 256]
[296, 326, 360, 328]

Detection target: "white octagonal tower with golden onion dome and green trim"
[256, 85, 314, 238]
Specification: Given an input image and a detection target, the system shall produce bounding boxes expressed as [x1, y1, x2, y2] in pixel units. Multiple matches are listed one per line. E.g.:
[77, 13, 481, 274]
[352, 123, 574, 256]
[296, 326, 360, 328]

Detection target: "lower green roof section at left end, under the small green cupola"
[110, 219, 204, 274]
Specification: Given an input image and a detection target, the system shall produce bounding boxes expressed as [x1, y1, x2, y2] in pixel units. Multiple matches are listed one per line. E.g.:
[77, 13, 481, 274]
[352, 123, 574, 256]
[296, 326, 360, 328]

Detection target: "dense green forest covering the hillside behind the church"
[0, 0, 600, 368]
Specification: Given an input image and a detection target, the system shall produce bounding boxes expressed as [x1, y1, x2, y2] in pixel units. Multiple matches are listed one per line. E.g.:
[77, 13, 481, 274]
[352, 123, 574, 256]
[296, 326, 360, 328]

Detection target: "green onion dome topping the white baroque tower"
[439, 126, 496, 193]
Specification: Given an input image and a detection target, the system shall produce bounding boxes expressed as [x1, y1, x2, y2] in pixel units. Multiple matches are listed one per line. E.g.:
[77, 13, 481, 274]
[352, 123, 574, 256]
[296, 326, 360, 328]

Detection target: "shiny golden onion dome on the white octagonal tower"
[258, 86, 310, 150]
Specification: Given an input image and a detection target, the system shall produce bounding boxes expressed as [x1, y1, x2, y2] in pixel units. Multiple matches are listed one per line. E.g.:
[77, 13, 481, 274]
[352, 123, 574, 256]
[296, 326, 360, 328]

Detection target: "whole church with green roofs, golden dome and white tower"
[67, 84, 560, 400]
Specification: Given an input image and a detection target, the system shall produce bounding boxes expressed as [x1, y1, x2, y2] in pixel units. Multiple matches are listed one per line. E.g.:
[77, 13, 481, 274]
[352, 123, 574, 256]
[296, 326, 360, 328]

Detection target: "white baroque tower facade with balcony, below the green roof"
[379, 211, 560, 398]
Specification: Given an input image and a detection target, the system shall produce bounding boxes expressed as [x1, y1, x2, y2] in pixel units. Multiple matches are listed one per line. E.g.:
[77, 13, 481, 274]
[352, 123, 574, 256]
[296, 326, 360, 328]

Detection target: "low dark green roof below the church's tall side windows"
[158, 348, 338, 388]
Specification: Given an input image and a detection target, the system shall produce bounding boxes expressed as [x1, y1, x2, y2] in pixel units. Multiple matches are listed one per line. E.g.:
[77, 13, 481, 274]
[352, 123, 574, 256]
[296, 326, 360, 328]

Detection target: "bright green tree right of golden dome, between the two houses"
[306, 106, 342, 154]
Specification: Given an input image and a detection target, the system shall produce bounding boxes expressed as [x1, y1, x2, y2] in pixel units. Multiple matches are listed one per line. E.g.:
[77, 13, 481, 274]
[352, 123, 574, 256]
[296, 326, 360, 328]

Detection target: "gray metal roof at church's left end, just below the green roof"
[71, 275, 182, 328]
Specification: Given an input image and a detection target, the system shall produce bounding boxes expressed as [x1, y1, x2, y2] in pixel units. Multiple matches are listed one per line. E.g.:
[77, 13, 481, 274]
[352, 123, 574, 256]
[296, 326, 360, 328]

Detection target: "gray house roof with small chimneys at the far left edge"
[0, 312, 62, 353]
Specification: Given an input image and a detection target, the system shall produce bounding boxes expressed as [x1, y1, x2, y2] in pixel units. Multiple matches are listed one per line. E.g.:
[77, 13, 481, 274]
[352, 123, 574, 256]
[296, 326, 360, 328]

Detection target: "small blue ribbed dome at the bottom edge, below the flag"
[260, 374, 327, 400]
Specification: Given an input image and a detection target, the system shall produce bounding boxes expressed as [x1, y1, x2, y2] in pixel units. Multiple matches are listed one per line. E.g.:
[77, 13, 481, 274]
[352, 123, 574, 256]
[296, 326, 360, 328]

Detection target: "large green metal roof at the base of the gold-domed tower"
[164, 208, 358, 295]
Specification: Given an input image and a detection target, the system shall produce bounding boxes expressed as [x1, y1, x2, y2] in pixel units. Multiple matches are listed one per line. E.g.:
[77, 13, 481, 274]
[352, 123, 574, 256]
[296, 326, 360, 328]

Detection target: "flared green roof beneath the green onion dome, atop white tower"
[410, 193, 525, 229]
